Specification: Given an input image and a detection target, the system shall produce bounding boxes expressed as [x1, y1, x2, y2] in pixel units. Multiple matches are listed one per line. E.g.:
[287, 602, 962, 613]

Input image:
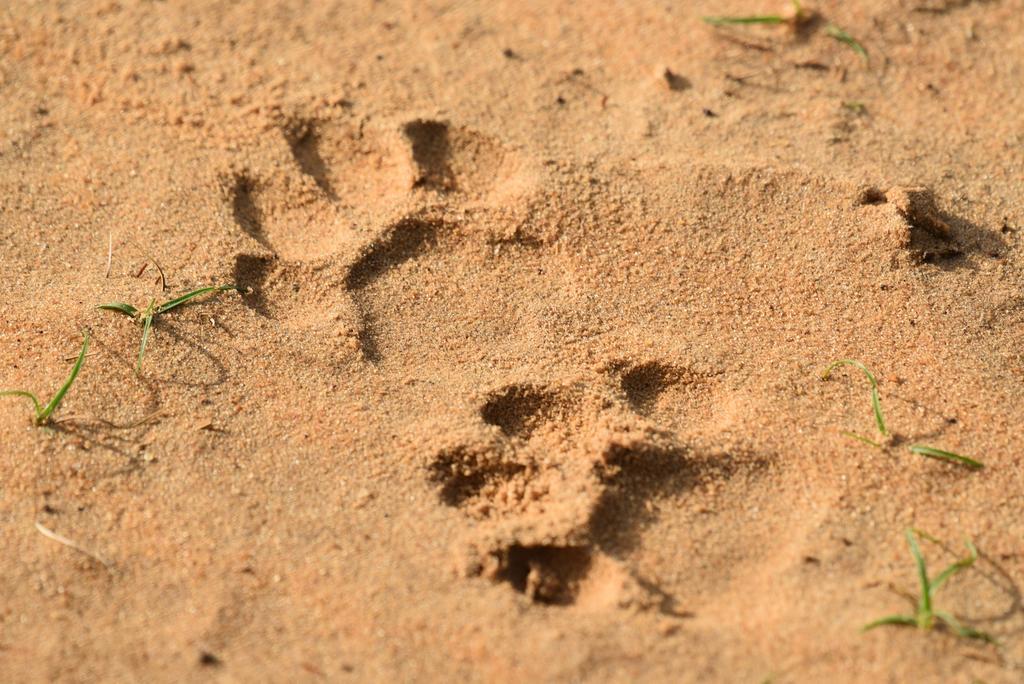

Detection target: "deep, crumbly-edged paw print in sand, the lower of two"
[429, 368, 687, 607]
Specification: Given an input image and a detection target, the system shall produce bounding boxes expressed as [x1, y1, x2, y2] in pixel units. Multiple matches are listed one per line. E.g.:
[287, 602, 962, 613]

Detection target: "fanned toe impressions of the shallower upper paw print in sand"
[221, 109, 521, 360]
